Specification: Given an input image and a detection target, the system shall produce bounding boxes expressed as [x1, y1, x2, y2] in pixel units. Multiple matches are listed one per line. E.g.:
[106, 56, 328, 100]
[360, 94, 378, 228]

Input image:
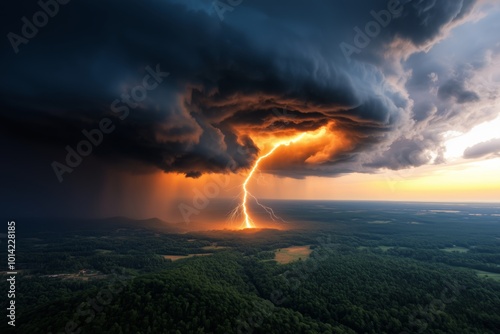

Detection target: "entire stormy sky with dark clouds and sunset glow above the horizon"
[0, 0, 500, 221]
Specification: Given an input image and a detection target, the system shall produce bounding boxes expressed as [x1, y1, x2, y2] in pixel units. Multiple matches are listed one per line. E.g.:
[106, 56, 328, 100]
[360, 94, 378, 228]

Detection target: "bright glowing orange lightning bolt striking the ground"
[235, 132, 306, 228]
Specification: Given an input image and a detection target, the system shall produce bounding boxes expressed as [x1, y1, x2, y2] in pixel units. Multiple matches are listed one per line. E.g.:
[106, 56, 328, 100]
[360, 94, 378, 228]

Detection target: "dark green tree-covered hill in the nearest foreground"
[11, 247, 500, 333]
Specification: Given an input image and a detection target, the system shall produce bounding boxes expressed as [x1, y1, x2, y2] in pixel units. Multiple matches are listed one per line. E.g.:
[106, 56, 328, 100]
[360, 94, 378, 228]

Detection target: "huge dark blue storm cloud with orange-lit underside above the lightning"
[0, 0, 484, 183]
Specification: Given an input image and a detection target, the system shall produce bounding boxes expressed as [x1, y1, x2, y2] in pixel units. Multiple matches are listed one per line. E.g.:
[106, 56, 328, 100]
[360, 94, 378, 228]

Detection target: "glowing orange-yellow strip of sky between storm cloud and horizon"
[95, 158, 500, 227]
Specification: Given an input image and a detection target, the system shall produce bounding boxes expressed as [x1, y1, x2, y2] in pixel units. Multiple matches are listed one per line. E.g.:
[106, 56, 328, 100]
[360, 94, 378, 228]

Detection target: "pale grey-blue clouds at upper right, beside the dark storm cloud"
[371, 0, 500, 169]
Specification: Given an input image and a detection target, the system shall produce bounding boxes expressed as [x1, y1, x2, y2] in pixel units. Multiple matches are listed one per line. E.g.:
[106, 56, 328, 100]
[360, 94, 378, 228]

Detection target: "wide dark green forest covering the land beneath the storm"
[0, 202, 500, 334]
